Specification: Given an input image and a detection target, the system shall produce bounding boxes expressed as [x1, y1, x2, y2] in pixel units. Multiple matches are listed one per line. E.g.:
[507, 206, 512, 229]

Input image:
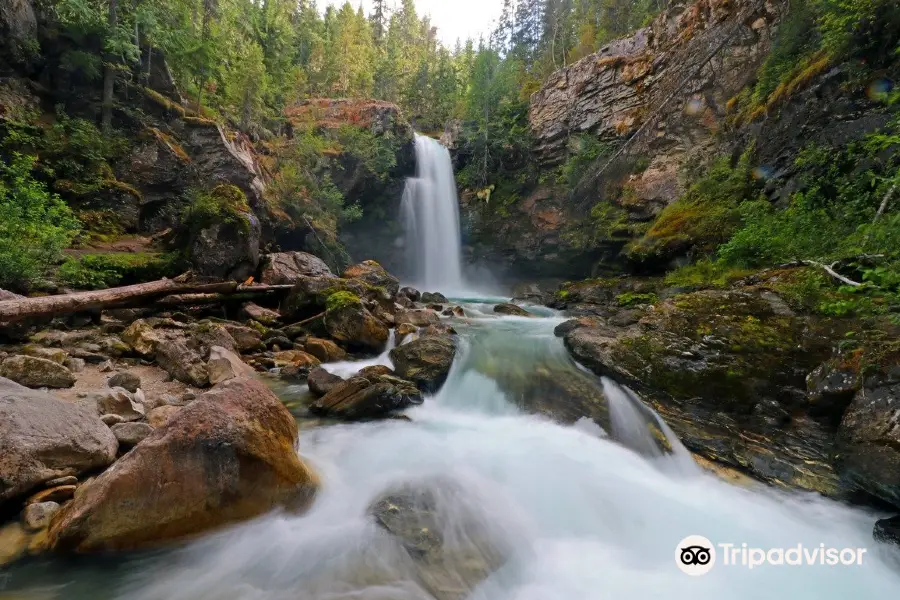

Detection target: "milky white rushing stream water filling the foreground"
[8, 304, 900, 600]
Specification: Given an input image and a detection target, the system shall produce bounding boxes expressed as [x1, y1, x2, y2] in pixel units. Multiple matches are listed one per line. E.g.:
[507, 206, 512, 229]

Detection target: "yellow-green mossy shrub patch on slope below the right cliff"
[626, 150, 759, 261]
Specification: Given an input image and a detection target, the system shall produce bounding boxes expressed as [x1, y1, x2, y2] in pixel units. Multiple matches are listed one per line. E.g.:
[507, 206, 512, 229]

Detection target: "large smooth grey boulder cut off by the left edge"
[0, 379, 118, 502]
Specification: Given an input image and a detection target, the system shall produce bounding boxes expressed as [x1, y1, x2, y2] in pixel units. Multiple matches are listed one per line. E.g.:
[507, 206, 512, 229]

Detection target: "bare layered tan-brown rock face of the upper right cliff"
[529, 0, 787, 164]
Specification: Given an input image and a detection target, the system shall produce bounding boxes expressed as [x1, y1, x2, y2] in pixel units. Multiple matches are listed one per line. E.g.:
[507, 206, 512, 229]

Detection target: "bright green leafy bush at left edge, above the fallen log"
[0, 153, 79, 290]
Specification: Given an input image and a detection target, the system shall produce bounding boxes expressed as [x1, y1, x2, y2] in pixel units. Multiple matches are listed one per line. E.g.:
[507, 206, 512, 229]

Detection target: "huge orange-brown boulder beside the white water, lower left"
[50, 379, 319, 552]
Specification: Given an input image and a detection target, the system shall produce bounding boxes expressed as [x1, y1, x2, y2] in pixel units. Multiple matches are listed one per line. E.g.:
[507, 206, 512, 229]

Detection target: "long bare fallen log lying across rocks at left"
[0, 273, 291, 324]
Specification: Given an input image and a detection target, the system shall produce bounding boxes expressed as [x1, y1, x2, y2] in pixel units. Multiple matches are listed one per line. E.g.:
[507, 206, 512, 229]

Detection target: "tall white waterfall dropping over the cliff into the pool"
[401, 134, 463, 292]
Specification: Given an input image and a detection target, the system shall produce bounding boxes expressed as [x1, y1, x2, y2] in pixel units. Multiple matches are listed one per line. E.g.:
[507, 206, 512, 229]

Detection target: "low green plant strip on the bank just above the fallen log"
[57, 252, 184, 290]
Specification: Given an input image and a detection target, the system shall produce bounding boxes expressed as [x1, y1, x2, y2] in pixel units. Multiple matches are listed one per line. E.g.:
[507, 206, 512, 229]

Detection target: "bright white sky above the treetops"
[319, 0, 503, 48]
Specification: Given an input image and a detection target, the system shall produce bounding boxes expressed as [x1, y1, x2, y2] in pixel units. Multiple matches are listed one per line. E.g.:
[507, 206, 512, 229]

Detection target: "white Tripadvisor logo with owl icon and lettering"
[675, 535, 867, 576]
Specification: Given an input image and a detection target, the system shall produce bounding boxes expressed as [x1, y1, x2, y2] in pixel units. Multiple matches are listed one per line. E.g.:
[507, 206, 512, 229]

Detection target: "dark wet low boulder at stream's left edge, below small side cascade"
[309, 375, 422, 421]
